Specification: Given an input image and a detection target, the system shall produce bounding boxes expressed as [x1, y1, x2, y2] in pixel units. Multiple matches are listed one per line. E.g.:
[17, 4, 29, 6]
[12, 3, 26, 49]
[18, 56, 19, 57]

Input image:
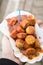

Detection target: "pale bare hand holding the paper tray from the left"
[2, 36, 23, 65]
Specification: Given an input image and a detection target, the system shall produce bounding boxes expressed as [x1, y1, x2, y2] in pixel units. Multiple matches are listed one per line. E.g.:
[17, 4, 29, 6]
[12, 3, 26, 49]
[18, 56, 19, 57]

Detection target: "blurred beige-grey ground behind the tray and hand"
[0, 0, 43, 65]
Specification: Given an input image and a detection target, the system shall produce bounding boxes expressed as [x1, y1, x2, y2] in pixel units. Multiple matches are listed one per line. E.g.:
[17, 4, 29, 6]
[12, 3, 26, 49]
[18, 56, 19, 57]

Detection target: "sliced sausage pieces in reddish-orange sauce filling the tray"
[6, 15, 41, 59]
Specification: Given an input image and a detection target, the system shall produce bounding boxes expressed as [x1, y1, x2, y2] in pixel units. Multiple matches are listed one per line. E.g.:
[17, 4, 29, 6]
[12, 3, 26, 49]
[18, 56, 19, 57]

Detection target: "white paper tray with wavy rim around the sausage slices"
[0, 11, 43, 64]
